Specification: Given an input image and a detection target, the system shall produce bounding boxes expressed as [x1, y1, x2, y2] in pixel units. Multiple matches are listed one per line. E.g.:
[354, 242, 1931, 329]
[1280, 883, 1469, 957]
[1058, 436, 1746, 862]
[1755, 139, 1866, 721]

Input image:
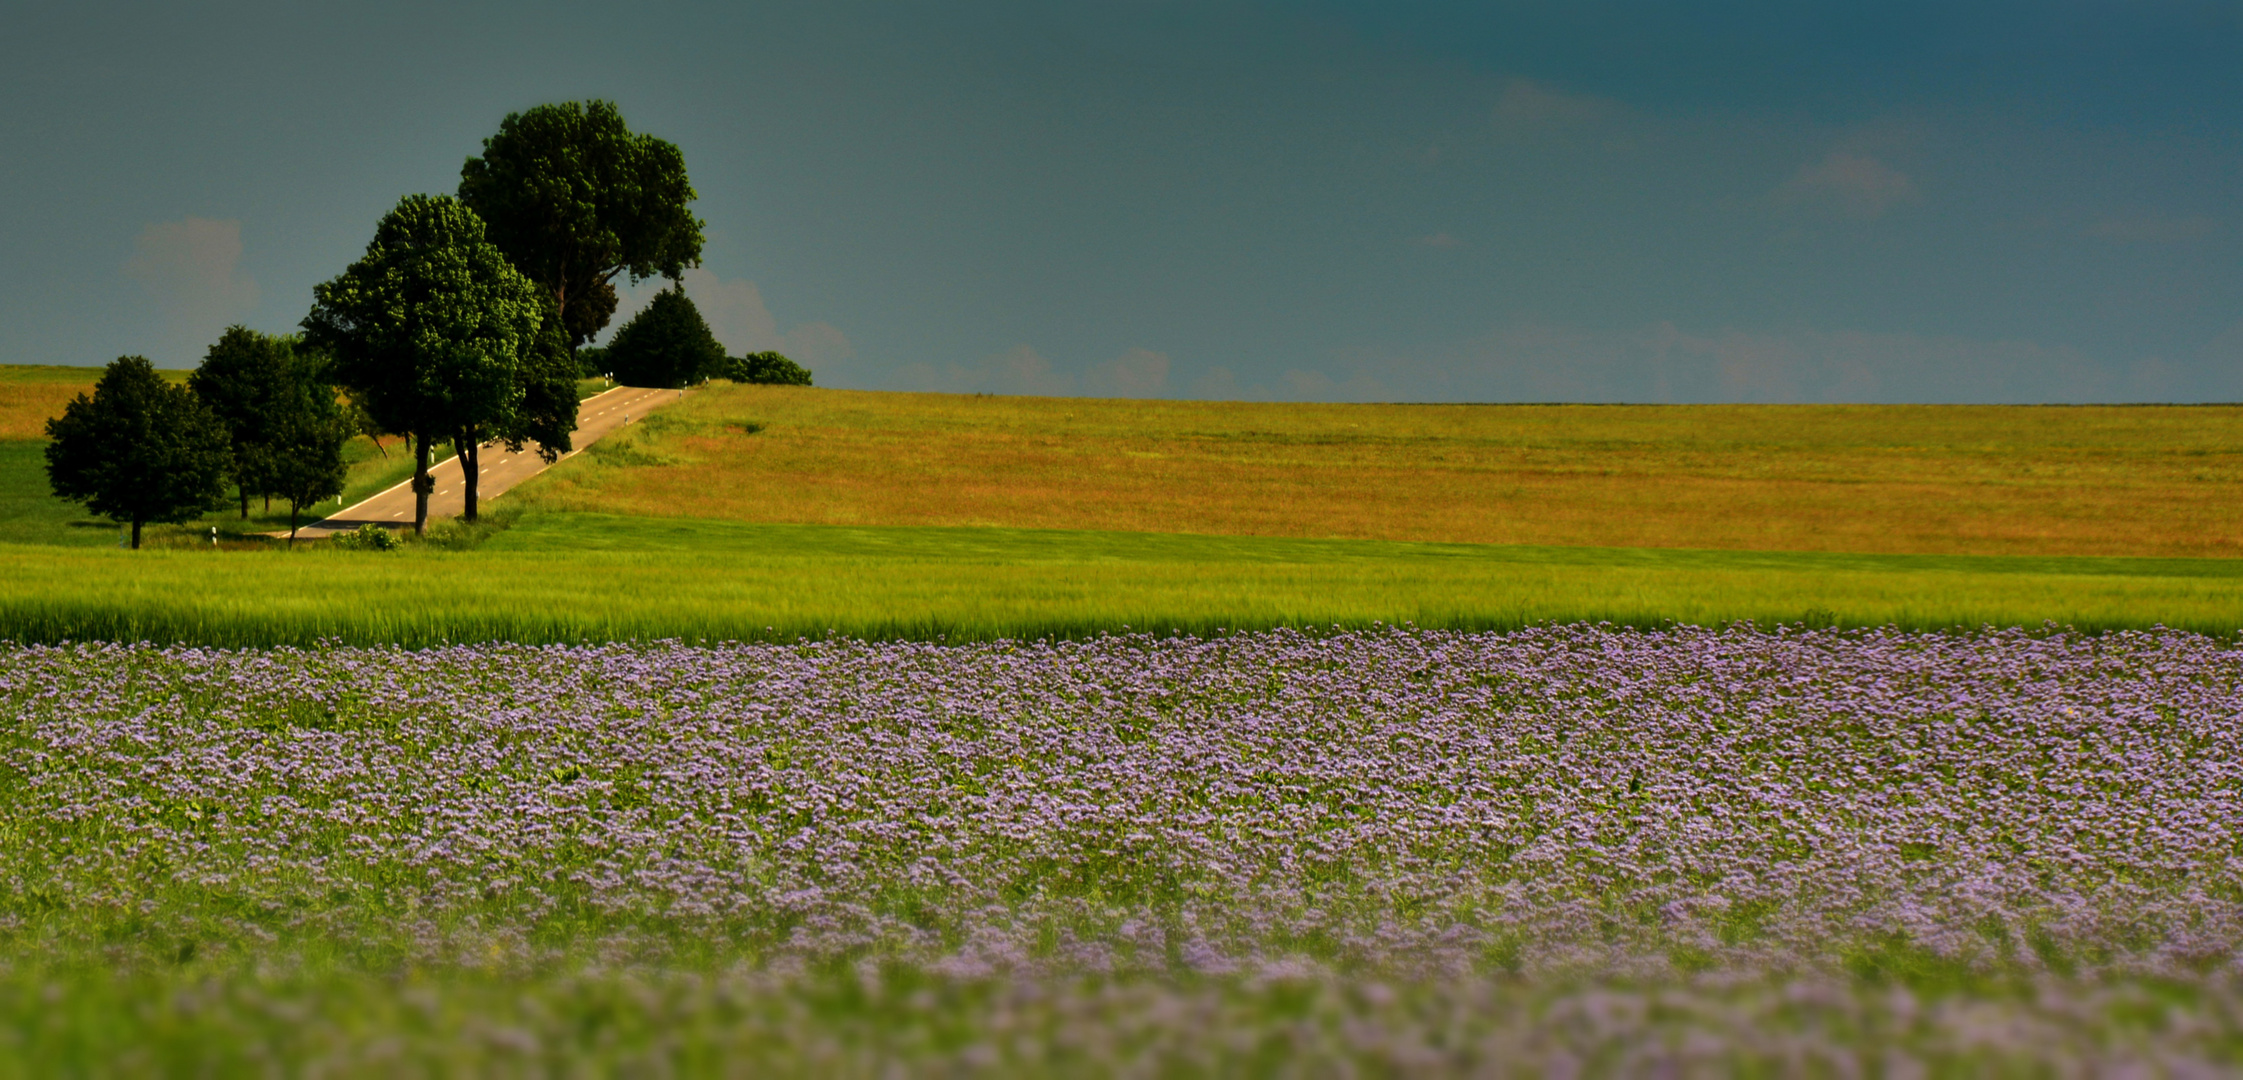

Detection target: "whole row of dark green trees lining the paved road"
[49, 101, 726, 548]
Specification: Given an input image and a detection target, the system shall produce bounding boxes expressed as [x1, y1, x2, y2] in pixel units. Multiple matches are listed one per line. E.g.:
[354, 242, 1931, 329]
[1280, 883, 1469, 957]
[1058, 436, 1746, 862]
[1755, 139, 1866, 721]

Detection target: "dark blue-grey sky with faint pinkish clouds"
[0, 0, 2243, 402]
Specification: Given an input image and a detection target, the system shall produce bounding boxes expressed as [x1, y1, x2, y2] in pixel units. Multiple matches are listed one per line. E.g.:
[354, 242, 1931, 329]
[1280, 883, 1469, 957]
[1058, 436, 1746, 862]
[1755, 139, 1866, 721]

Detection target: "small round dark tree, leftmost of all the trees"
[47, 357, 231, 550]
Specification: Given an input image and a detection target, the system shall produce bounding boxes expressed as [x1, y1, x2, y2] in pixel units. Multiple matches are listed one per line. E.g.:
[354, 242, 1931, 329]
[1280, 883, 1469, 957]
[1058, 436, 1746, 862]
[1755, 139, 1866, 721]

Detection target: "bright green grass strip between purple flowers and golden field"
[0, 510, 2243, 644]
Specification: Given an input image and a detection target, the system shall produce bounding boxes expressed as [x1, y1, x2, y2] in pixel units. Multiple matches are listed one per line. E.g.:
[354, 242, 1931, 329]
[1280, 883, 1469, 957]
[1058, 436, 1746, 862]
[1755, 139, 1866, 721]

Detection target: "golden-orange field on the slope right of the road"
[525, 384, 2243, 557]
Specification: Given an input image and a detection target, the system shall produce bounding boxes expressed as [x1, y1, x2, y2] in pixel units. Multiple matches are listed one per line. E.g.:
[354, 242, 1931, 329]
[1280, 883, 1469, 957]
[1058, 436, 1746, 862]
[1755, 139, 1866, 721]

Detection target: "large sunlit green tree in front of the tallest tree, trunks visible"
[303, 195, 545, 532]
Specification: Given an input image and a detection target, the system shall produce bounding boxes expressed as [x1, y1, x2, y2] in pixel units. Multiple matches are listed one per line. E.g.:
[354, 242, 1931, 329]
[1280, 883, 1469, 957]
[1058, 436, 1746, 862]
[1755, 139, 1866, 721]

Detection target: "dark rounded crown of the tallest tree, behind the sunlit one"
[460, 101, 702, 346]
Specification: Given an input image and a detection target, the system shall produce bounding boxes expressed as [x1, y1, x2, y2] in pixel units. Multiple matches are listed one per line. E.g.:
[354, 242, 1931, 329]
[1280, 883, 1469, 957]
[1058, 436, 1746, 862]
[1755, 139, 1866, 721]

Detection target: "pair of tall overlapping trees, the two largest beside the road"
[303, 101, 702, 532]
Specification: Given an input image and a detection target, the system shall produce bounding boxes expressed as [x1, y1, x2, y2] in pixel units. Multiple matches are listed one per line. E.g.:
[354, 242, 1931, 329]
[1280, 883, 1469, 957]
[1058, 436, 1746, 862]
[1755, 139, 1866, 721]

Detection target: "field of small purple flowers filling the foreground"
[0, 624, 2243, 1076]
